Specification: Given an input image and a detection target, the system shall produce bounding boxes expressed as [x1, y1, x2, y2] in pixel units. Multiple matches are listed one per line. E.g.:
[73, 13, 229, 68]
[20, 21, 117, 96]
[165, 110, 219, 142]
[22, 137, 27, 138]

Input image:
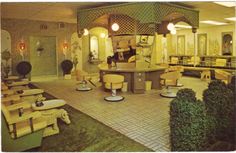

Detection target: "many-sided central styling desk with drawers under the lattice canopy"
[99, 65, 165, 93]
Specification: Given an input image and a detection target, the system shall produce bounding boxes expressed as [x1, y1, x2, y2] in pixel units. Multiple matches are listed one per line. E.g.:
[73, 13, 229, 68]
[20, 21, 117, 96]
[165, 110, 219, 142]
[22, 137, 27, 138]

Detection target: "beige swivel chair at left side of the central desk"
[76, 70, 96, 91]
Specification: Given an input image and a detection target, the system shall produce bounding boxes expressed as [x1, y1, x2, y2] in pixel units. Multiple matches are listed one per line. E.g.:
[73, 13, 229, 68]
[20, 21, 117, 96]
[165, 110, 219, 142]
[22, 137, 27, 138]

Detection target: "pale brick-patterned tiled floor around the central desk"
[33, 77, 207, 151]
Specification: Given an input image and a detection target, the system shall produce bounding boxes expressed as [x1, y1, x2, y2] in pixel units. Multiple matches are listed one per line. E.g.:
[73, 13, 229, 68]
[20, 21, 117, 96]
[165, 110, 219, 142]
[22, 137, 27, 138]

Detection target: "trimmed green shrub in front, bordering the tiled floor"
[170, 89, 206, 151]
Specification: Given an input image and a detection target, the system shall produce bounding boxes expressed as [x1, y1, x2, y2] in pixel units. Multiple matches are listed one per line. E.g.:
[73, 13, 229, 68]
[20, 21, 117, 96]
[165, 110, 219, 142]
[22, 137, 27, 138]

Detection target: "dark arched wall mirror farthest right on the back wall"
[222, 32, 233, 55]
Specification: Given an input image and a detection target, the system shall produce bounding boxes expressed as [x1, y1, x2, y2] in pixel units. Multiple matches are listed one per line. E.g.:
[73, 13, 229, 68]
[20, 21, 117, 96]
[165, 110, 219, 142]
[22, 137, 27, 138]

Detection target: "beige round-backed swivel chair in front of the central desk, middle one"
[103, 74, 124, 102]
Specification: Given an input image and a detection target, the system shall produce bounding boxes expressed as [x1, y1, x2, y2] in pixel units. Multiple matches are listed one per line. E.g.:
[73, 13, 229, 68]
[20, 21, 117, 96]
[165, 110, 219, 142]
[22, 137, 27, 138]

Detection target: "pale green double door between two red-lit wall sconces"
[30, 36, 57, 77]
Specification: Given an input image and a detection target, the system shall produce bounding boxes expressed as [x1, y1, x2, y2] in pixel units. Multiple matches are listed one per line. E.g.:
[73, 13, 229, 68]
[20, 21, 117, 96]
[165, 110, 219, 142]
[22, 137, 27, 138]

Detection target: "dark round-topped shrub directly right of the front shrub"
[203, 80, 235, 142]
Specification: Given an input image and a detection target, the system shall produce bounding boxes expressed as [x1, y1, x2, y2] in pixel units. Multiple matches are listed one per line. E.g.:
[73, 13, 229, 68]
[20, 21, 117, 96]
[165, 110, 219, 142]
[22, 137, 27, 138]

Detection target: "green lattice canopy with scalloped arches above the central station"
[78, 2, 199, 35]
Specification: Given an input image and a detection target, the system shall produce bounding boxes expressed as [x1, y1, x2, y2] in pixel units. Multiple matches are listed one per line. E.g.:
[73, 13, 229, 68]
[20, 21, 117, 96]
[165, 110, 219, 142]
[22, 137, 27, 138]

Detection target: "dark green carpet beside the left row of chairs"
[28, 85, 152, 152]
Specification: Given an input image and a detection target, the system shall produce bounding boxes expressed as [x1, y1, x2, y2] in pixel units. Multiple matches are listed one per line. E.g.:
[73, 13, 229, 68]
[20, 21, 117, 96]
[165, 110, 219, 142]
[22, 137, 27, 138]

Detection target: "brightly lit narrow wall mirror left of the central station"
[89, 36, 98, 60]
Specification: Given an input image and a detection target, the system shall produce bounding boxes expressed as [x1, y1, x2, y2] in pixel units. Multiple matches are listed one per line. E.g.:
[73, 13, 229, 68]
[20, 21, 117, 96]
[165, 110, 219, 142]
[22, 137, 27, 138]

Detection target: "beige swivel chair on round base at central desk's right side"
[160, 71, 181, 98]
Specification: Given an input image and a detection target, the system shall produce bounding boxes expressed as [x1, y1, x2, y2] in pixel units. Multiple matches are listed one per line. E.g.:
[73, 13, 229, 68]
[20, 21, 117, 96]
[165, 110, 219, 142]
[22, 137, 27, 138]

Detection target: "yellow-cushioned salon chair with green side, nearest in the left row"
[1, 103, 47, 152]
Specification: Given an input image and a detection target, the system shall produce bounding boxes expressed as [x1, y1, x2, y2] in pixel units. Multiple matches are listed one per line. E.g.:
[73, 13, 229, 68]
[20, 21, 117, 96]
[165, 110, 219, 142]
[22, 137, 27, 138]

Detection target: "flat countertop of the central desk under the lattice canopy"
[99, 65, 166, 72]
